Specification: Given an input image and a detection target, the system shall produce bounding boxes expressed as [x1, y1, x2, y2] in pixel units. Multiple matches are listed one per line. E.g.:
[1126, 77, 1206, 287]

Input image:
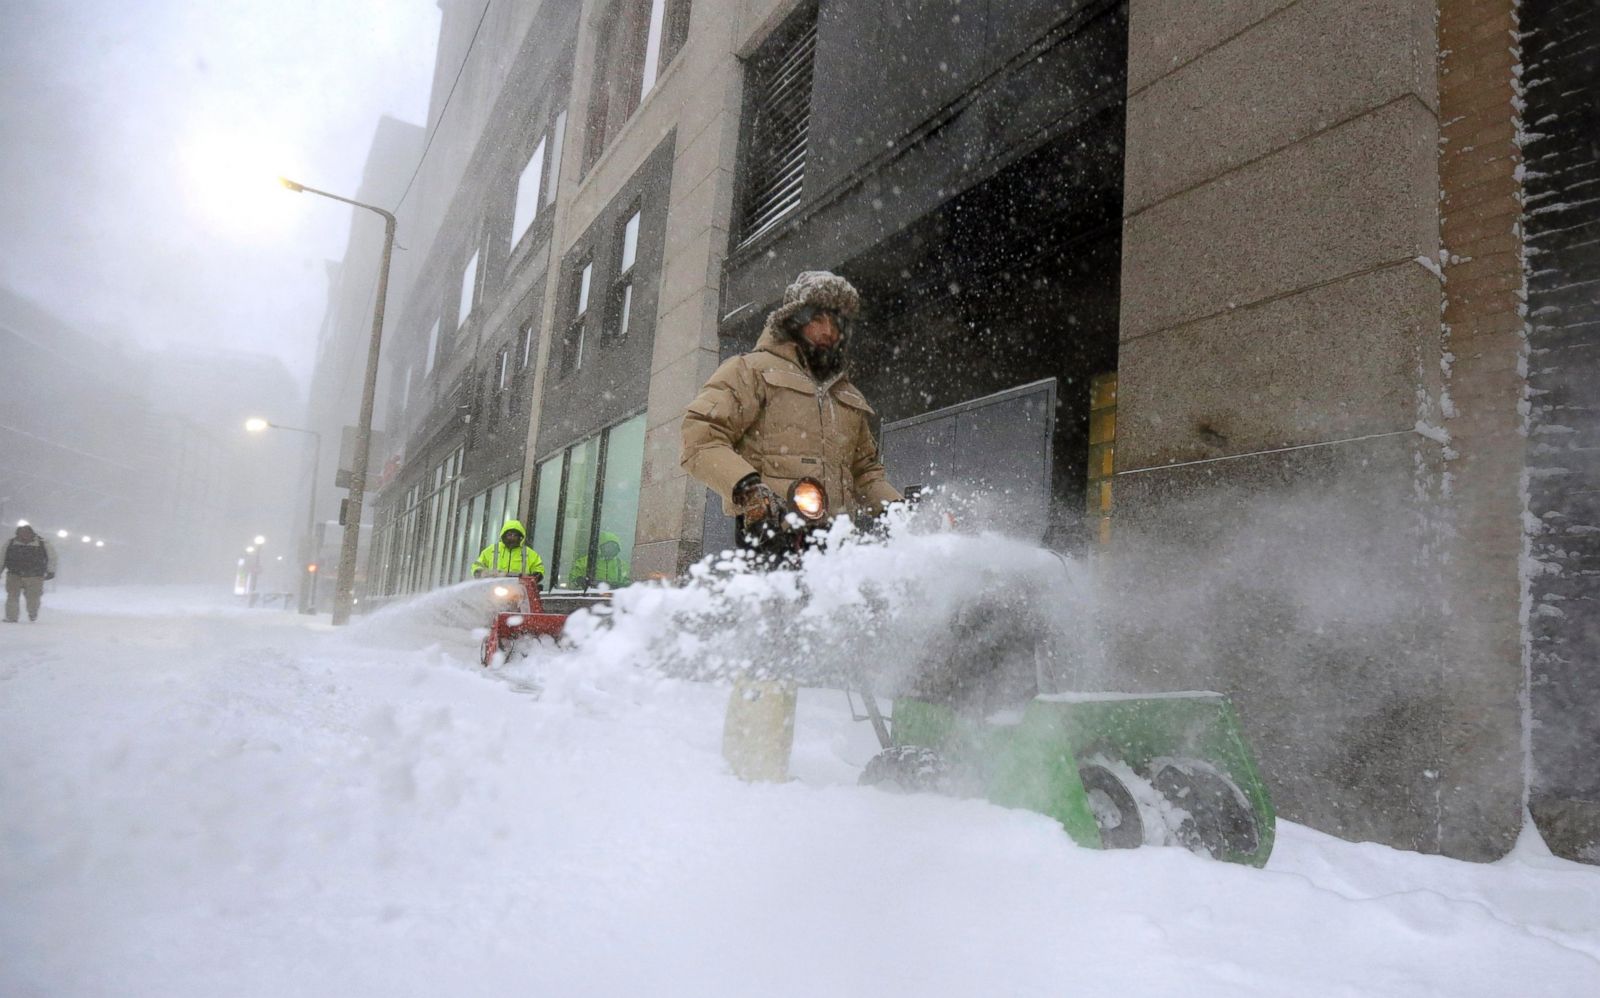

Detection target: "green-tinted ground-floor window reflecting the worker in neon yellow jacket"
[530, 416, 645, 589]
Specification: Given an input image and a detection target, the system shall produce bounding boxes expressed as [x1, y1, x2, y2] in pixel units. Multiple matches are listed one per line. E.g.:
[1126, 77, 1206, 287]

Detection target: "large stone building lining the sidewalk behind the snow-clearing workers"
[344, 0, 1600, 859]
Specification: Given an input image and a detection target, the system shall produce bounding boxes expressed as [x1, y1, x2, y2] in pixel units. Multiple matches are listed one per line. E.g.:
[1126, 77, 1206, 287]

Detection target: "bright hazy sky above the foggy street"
[0, 0, 438, 390]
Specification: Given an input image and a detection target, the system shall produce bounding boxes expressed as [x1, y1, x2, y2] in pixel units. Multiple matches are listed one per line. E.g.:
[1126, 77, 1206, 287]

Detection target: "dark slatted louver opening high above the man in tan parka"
[741, 11, 816, 240]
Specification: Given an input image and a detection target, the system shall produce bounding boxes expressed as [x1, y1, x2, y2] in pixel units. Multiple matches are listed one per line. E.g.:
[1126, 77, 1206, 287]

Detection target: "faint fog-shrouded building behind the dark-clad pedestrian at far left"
[0, 289, 299, 584]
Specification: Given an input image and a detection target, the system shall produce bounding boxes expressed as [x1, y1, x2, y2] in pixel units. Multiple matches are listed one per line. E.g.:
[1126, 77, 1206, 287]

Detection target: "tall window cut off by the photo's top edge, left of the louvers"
[582, 0, 690, 173]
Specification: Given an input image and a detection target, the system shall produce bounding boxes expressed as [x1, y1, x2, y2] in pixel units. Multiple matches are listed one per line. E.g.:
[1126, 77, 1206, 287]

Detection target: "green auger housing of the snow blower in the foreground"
[862, 693, 1277, 867]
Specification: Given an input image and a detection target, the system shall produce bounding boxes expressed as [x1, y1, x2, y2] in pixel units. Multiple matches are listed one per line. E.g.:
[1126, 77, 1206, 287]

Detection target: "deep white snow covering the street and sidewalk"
[0, 589, 1600, 998]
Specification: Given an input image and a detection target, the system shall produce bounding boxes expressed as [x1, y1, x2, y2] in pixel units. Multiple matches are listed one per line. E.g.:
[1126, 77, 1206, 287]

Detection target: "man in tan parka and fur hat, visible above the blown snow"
[682, 270, 901, 534]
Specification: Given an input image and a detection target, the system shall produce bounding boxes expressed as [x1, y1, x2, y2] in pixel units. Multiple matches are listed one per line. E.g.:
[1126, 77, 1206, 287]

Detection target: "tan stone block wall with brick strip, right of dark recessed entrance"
[1109, 0, 1525, 859]
